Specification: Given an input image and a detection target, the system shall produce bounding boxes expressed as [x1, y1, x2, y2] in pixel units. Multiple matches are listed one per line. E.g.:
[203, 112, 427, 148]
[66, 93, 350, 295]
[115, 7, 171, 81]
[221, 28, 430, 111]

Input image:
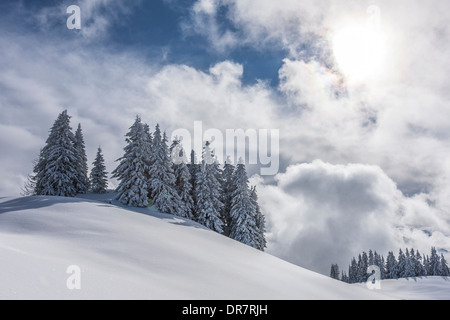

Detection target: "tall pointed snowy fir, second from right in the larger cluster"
[230, 159, 261, 249]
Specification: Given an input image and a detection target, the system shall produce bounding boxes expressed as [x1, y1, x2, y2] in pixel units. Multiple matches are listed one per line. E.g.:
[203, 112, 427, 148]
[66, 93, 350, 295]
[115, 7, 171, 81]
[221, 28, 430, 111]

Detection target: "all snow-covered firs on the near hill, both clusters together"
[25, 111, 266, 251]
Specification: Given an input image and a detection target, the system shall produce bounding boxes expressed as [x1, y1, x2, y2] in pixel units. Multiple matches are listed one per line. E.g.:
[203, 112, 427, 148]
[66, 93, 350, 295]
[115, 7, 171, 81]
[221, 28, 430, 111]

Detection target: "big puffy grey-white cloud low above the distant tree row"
[252, 160, 450, 274]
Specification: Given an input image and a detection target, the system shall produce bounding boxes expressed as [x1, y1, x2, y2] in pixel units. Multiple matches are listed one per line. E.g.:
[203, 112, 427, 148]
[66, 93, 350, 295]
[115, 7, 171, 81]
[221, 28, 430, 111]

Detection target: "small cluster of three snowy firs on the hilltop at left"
[24, 110, 108, 197]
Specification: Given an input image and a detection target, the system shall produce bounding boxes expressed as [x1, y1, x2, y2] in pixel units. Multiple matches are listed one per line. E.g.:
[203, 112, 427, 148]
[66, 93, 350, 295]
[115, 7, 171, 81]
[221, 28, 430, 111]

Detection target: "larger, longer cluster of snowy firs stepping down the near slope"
[112, 116, 266, 250]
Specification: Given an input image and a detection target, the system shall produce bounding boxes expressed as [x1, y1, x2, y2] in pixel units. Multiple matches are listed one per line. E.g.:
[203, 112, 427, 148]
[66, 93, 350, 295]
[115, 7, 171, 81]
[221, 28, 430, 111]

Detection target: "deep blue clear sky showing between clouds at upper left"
[0, 0, 285, 86]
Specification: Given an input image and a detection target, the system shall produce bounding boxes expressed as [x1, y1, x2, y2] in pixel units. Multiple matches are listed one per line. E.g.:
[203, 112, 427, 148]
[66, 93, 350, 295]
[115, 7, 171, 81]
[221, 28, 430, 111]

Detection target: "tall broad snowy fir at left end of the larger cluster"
[112, 116, 150, 207]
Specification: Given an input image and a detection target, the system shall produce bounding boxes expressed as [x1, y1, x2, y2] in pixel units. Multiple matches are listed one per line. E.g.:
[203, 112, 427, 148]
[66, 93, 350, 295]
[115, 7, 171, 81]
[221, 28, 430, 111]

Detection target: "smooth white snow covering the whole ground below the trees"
[0, 194, 450, 300]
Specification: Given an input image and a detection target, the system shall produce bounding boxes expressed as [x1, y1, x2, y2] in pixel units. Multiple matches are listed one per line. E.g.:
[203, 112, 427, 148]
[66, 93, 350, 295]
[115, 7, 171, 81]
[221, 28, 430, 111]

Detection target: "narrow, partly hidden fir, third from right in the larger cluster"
[222, 157, 235, 237]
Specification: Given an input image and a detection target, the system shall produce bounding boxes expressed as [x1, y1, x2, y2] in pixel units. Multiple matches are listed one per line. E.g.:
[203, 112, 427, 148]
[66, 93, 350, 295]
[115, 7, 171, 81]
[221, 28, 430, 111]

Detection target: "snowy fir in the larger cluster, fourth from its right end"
[195, 162, 223, 233]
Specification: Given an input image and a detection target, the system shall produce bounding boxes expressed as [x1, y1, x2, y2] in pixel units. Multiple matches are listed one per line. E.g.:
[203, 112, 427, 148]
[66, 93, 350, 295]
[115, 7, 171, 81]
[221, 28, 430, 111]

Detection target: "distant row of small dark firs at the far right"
[330, 247, 450, 283]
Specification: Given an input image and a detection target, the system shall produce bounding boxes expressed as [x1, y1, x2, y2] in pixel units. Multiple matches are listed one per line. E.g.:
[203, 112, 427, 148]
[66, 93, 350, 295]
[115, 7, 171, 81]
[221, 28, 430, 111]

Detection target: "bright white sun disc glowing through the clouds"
[332, 26, 385, 82]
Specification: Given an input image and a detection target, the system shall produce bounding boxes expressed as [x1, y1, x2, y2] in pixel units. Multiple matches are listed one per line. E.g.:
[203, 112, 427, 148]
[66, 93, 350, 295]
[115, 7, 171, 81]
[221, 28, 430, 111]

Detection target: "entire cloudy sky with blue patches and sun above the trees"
[0, 0, 450, 274]
